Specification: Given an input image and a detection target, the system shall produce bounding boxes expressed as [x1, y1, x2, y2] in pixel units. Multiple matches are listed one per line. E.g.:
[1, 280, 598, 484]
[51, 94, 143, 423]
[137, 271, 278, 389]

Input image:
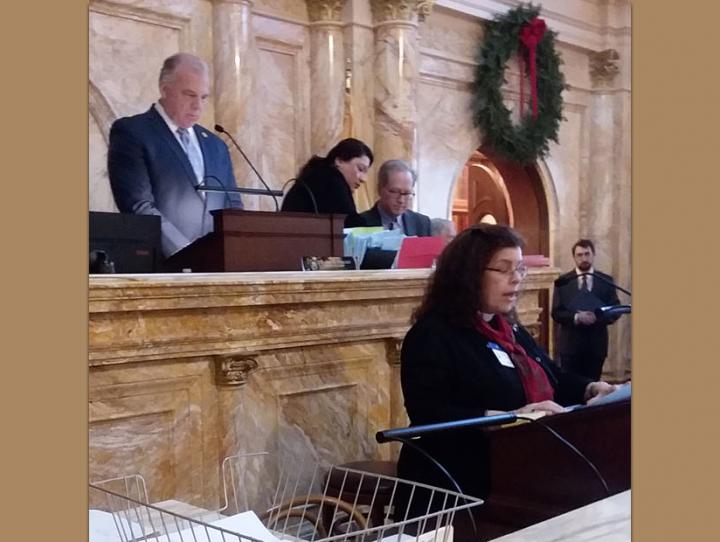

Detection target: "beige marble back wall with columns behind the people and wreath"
[88, 0, 631, 372]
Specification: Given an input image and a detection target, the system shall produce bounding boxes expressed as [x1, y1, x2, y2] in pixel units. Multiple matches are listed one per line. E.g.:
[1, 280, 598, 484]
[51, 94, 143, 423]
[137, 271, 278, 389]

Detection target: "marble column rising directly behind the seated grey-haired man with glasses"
[371, 0, 432, 202]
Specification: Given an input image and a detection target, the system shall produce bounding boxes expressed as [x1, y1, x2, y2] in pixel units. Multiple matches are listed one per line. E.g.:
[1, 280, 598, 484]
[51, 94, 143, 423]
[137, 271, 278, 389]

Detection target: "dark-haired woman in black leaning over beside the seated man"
[282, 138, 373, 227]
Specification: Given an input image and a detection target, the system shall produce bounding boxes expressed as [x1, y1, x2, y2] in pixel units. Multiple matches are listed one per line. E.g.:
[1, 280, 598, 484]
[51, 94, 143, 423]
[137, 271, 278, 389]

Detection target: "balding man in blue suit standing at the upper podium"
[108, 53, 243, 257]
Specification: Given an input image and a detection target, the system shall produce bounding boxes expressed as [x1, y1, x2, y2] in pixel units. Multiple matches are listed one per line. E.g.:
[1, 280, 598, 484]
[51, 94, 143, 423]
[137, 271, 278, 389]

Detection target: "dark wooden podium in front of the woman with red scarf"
[477, 400, 630, 540]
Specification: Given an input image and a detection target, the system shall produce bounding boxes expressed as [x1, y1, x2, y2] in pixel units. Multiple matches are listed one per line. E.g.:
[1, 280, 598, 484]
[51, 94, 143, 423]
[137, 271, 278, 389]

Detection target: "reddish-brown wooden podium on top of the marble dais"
[163, 209, 345, 273]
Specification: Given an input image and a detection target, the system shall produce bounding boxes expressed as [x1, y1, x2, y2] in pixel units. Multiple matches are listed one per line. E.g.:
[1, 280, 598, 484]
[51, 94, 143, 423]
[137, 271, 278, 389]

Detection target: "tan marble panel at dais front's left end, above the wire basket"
[89, 361, 219, 510]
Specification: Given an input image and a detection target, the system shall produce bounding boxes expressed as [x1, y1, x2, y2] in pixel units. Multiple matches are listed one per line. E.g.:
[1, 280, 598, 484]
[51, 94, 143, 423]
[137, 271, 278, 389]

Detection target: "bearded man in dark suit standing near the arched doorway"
[552, 239, 620, 381]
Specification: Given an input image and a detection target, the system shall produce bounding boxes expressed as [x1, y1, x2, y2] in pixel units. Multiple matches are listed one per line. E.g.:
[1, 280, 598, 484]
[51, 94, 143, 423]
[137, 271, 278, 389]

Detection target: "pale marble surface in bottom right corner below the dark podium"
[491, 490, 630, 542]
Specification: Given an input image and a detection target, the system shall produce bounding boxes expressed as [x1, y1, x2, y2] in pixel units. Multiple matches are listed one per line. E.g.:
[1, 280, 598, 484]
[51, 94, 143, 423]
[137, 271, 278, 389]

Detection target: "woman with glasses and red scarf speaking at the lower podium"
[398, 224, 615, 516]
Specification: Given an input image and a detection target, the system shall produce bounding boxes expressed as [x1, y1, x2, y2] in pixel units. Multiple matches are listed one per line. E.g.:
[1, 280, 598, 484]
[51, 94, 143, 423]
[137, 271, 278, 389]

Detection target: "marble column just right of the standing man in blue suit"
[213, 0, 261, 209]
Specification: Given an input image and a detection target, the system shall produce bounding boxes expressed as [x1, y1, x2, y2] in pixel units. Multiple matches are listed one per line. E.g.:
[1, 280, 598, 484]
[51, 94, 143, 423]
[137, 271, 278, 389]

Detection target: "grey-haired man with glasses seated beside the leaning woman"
[360, 160, 431, 237]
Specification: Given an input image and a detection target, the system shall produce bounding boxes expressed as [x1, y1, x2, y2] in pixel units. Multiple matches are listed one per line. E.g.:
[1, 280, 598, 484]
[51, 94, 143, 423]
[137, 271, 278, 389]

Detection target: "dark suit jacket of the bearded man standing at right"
[552, 271, 620, 358]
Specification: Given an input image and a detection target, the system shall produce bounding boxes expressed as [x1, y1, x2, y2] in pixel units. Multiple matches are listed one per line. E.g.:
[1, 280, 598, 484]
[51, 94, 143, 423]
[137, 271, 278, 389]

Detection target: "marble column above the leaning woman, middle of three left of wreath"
[305, 0, 345, 155]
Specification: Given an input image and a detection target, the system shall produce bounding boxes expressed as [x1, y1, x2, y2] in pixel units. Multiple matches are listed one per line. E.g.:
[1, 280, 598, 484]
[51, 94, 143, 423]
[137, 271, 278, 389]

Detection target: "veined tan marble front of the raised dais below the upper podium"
[88, 268, 558, 509]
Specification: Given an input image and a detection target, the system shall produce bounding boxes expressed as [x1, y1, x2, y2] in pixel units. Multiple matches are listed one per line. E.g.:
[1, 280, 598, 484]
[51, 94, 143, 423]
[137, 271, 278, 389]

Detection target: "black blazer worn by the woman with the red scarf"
[398, 315, 590, 497]
